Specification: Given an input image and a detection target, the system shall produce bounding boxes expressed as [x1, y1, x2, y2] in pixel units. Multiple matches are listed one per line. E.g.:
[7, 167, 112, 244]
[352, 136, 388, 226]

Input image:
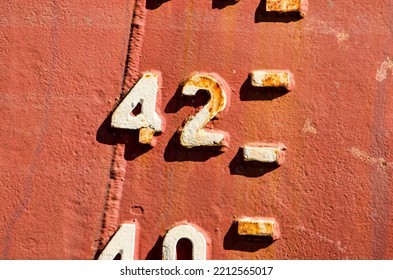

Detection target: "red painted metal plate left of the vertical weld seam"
[0, 0, 133, 259]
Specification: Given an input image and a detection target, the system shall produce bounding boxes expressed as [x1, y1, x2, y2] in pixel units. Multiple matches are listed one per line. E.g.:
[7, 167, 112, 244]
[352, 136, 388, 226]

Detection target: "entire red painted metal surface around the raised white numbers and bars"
[0, 0, 393, 259]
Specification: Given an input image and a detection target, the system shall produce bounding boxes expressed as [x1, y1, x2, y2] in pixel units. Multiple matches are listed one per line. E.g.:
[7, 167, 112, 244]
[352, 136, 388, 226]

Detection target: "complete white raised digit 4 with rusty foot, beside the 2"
[111, 72, 161, 144]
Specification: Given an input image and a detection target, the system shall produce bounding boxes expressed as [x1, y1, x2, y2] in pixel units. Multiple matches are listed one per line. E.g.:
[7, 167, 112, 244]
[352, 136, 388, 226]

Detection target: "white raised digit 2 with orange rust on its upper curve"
[180, 74, 227, 148]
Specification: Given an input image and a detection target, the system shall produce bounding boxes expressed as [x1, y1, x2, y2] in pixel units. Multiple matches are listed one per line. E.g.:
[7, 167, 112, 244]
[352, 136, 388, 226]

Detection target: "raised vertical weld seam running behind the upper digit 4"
[96, 0, 147, 257]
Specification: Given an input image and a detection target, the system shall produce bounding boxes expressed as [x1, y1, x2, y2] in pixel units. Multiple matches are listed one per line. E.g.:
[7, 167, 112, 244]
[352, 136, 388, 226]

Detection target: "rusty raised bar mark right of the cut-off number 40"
[237, 218, 280, 240]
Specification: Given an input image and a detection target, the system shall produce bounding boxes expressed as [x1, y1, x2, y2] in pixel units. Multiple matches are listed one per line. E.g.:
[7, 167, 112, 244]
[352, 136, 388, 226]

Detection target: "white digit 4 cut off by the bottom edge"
[98, 224, 136, 260]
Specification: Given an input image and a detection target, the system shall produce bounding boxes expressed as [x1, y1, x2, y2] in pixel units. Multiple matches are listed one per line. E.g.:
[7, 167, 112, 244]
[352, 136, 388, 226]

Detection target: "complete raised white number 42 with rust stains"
[111, 72, 227, 148]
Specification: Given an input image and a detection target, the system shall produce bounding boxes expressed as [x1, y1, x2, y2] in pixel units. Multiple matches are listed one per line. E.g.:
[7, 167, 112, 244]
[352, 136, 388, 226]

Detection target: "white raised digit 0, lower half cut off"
[162, 225, 206, 260]
